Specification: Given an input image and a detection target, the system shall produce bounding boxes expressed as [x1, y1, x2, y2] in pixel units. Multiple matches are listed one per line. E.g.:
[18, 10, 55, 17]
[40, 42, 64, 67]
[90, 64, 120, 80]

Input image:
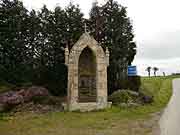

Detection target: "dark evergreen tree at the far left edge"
[0, 0, 28, 83]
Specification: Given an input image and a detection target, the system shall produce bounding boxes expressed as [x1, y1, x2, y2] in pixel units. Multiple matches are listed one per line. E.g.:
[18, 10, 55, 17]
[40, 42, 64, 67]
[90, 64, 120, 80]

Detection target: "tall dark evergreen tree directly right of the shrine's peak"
[90, 0, 136, 92]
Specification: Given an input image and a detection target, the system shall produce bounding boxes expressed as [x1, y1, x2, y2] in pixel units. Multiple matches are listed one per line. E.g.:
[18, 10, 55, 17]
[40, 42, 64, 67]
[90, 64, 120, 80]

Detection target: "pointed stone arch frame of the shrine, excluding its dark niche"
[65, 33, 109, 111]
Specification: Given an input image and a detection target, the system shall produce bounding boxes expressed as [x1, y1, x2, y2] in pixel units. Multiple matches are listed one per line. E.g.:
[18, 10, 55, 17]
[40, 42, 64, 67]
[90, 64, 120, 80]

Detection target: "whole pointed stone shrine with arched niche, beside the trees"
[65, 31, 109, 111]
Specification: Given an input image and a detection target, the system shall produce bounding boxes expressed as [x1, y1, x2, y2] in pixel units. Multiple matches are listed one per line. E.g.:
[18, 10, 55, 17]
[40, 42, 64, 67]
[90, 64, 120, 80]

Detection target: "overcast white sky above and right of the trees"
[21, 0, 180, 75]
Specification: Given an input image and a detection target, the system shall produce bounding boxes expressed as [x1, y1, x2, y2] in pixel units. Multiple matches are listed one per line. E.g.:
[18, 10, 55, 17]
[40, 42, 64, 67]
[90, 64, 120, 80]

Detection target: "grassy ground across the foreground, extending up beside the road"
[0, 76, 176, 135]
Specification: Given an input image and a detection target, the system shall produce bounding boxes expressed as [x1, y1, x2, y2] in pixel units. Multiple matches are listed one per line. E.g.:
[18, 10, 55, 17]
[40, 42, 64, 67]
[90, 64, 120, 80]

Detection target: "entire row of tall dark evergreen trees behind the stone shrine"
[0, 0, 136, 95]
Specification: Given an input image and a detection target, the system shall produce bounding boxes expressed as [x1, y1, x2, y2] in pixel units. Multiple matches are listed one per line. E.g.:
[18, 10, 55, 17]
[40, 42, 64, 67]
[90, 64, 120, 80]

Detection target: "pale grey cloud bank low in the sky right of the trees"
[137, 30, 180, 60]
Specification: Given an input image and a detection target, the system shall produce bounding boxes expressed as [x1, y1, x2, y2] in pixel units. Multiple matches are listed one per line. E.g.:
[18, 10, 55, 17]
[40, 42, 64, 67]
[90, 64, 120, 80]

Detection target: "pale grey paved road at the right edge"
[159, 79, 180, 135]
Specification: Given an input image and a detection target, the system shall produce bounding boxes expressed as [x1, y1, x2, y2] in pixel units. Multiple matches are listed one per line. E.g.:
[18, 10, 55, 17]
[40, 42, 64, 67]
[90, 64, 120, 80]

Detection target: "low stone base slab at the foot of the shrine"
[62, 102, 112, 112]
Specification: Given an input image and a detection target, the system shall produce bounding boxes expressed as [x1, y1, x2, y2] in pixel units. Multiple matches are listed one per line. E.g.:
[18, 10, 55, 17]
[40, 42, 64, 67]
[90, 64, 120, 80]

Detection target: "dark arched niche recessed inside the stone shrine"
[78, 47, 97, 102]
